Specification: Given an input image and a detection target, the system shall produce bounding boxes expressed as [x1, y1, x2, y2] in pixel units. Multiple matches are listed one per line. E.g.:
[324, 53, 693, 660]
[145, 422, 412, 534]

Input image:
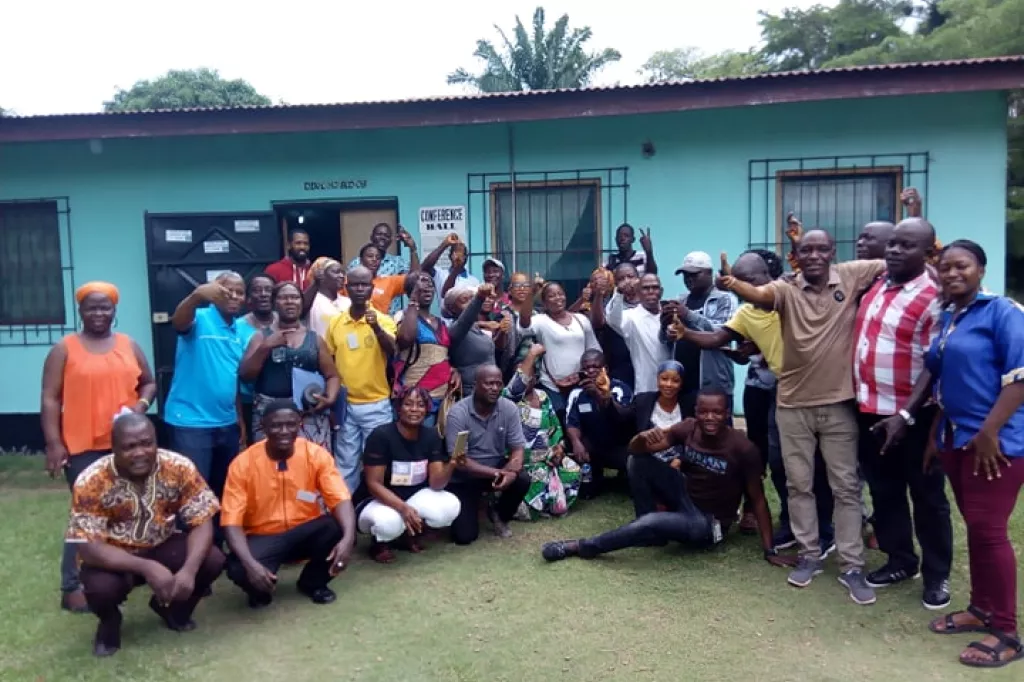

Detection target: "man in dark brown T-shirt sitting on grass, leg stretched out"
[542, 390, 796, 566]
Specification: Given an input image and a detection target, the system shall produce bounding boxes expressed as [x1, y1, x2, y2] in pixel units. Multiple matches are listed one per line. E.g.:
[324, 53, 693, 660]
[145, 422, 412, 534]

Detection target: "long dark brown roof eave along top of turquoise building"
[0, 60, 1024, 142]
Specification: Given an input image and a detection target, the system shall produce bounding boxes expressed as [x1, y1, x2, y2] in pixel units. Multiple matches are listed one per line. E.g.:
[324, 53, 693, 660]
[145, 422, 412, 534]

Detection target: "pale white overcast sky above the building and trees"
[0, 0, 835, 116]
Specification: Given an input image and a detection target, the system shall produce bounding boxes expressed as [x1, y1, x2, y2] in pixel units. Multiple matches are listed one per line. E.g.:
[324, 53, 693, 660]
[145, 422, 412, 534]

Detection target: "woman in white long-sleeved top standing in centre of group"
[519, 282, 601, 413]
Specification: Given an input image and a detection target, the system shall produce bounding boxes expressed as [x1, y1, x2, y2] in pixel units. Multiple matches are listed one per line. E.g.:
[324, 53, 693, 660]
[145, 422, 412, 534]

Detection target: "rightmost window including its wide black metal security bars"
[749, 153, 929, 261]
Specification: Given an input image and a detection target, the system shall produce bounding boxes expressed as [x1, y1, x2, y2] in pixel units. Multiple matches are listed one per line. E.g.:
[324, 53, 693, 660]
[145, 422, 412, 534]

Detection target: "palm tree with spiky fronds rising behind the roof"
[447, 7, 622, 92]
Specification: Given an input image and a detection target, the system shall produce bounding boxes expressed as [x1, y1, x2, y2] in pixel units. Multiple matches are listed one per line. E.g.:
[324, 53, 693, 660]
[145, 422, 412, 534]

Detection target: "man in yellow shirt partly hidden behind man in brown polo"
[669, 252, 836, 558]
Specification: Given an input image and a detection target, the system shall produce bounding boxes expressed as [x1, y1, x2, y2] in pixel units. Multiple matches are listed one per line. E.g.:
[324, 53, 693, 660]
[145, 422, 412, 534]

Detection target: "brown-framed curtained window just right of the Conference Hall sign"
[490, 179, 601, 296]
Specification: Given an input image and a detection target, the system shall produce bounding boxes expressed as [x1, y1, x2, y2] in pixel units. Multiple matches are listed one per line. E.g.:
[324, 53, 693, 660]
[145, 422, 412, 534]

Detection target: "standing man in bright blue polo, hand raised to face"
[164, 272, 255, 498]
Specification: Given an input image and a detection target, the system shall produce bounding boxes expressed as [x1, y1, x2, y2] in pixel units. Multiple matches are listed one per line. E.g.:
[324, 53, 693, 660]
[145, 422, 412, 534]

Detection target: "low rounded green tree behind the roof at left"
[103, 69, 270, 112]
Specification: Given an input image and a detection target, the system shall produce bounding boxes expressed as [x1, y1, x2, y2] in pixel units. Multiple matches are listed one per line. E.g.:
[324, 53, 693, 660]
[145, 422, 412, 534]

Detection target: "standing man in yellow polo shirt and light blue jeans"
[324, 266, 397, 492]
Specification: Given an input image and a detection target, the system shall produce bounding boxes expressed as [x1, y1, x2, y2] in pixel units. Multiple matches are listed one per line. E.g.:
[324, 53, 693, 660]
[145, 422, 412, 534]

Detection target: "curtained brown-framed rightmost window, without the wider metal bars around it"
[778, 168, 902, 261]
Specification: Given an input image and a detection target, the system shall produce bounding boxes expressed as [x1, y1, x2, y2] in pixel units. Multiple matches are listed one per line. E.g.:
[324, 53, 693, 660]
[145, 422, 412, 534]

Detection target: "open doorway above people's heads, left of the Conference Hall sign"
[273, 199, 398, 265]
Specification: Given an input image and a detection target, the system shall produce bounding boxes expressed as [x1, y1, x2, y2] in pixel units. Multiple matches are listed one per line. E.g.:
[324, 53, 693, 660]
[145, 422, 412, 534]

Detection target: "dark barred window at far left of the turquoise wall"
[0, 200, 67, 327]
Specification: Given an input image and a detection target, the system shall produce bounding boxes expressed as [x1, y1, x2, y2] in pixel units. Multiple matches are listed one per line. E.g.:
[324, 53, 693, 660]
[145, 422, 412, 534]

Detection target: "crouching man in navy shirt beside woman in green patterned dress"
[565, 350, 633, 497]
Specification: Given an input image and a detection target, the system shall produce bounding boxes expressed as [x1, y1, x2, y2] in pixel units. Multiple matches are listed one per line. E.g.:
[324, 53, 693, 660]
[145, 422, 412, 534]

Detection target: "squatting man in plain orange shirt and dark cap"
[220, 398, 355, 608]
